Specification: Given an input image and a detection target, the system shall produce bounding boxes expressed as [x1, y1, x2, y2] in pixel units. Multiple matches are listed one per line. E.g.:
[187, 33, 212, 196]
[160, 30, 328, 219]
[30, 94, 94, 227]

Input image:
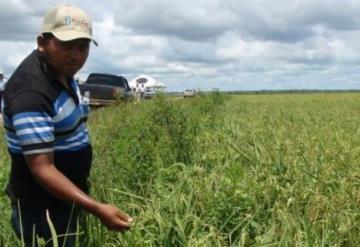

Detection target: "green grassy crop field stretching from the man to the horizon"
[0, 93, 360, 246]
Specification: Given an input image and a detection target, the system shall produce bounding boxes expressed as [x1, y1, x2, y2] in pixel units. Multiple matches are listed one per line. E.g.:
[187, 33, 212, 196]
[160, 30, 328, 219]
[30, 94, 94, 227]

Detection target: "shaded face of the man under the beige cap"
[38, 37, 90, 77]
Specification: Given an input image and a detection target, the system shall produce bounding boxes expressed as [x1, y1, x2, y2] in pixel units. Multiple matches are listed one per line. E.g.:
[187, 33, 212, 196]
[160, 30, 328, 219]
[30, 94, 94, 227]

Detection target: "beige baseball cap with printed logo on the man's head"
[41, 4, 98, 46]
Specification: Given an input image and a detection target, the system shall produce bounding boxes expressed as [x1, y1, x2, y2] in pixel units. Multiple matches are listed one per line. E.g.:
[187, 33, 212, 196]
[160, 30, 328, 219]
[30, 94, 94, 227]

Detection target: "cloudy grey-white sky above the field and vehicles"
[0, 0, 360, 91]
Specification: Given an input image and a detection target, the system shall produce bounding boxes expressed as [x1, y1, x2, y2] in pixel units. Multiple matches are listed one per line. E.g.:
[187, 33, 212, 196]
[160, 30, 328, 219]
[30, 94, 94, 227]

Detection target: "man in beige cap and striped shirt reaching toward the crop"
[3, 5, 132, 246]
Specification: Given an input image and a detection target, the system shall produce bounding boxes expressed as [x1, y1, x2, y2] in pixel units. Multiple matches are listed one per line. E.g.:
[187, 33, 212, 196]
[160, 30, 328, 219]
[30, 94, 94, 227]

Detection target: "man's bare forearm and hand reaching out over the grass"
[25, 153, 132, 231]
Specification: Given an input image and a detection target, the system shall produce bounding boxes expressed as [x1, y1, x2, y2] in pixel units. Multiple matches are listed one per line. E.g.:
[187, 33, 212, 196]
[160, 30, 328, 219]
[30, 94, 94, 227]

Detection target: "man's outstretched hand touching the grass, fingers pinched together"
[95, 203, 133, 232]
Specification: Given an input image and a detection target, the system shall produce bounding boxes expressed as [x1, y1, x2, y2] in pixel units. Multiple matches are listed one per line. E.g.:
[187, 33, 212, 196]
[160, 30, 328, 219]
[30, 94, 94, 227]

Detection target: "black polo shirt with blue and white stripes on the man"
[3, 51, 92, 210]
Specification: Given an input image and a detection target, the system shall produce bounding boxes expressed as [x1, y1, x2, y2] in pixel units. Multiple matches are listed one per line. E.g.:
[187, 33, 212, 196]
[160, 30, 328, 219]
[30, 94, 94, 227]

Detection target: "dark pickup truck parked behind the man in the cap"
[79, 73, 132, 106]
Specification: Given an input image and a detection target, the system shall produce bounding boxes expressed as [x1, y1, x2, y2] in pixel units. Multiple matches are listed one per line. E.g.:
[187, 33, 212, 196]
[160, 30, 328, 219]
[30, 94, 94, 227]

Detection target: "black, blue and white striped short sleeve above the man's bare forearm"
[10, 92, 55, 155]
